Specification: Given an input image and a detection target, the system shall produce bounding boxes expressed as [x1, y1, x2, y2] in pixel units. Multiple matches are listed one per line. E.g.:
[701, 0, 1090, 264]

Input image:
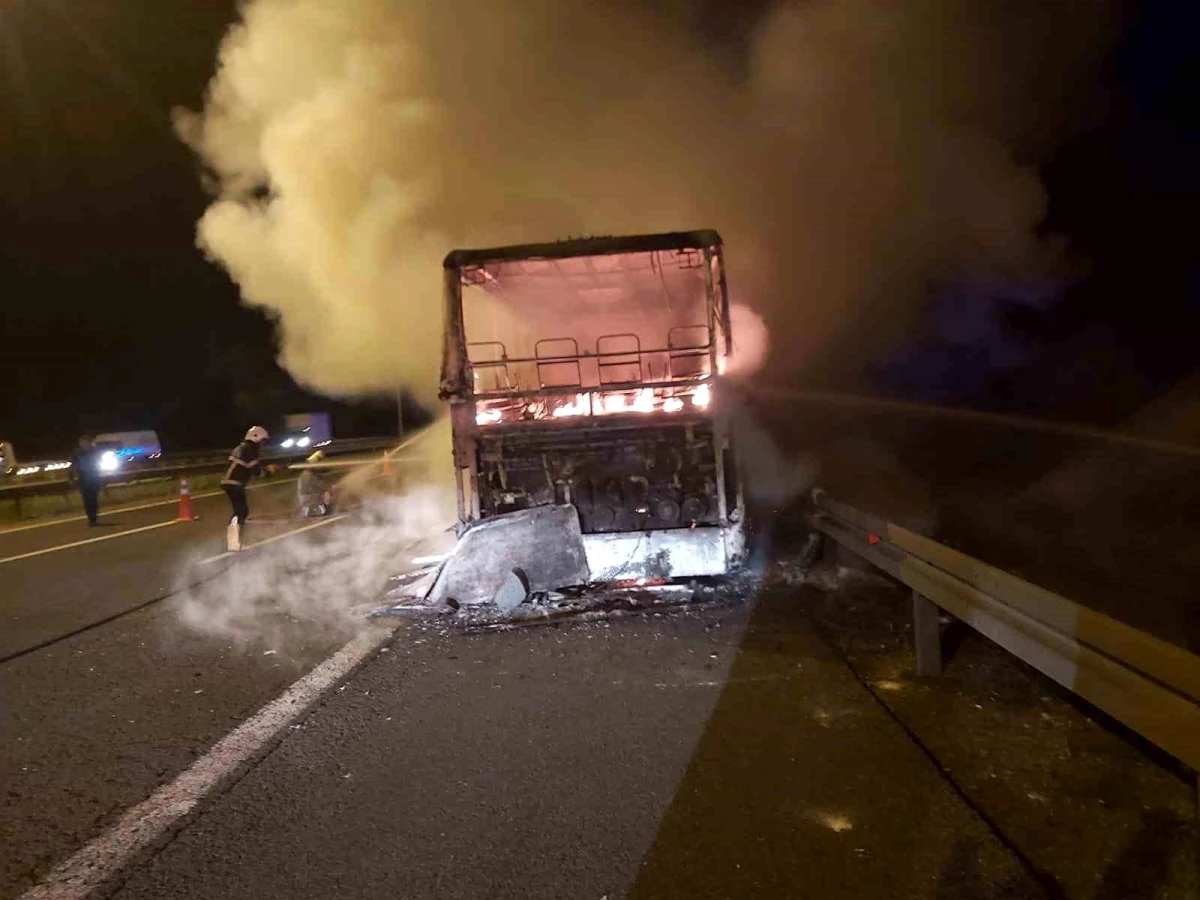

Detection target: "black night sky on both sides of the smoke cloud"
[0, 0, 1200, 456]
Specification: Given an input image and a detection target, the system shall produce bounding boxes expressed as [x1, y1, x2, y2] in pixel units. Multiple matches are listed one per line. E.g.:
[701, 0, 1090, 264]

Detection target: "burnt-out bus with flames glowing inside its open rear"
[440, 230, 744, 587]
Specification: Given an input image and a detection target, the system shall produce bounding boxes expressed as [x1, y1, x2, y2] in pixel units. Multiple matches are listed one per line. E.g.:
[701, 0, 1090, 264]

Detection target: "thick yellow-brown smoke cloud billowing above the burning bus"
[176, 0, 1111, 397]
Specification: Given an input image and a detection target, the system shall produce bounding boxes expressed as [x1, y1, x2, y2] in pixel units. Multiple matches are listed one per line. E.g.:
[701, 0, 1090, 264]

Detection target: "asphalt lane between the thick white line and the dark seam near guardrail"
[108, 607, 1036, 900]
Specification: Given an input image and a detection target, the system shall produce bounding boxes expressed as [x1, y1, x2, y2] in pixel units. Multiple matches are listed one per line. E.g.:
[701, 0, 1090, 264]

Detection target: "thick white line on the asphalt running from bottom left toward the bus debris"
[20, 625, 397, 900]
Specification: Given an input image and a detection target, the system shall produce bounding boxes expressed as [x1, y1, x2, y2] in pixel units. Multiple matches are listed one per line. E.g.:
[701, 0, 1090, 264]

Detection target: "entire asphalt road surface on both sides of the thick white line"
[0, 485, 1196, 900]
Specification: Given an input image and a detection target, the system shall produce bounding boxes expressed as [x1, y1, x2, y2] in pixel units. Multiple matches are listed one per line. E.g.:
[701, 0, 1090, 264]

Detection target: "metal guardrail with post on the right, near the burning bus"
[812, 491, 1200, 769]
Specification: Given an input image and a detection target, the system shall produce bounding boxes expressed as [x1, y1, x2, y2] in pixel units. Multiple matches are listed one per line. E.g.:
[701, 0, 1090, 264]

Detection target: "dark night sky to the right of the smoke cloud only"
[872, 2, 1200, 426]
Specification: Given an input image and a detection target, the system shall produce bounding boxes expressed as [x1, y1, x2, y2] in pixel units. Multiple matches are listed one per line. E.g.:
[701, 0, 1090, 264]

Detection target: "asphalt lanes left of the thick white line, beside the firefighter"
[0, 482, 355, 898]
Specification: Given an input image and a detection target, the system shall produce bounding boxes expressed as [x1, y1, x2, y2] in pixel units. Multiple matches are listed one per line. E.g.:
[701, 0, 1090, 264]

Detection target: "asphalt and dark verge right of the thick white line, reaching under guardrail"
[105, 582, 1195, 900]
